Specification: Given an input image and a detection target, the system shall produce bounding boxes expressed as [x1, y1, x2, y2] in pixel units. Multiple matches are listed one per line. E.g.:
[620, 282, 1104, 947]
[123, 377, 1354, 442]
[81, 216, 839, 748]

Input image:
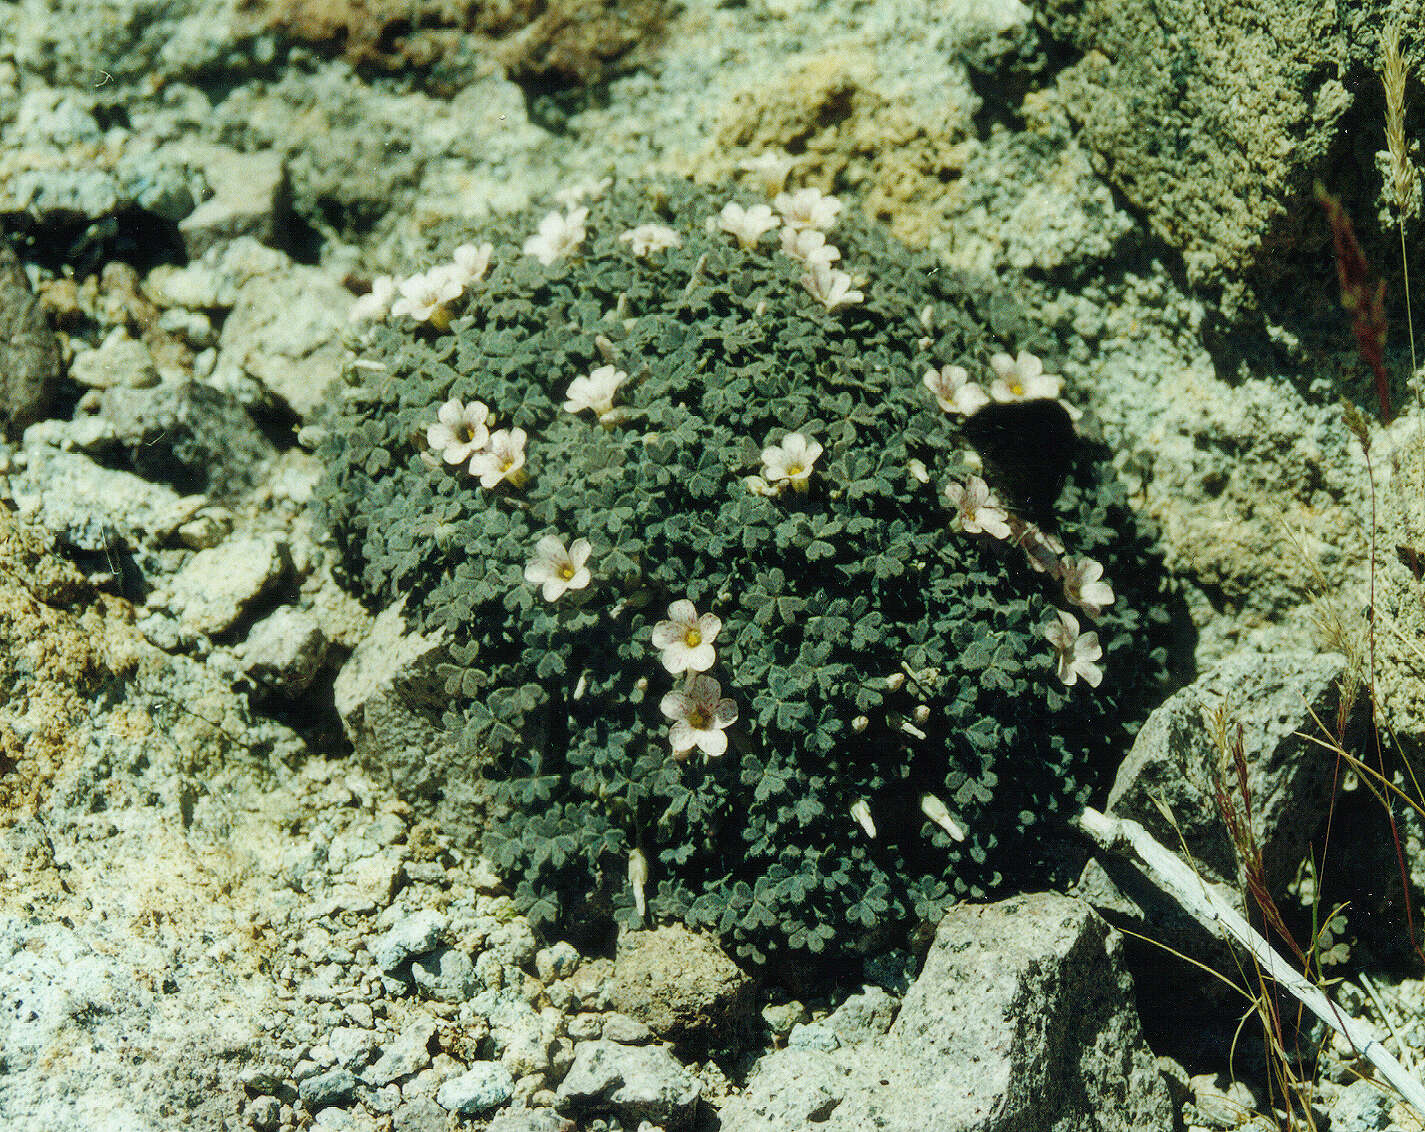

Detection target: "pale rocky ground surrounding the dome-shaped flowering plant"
[8, 0, 1425, 1132]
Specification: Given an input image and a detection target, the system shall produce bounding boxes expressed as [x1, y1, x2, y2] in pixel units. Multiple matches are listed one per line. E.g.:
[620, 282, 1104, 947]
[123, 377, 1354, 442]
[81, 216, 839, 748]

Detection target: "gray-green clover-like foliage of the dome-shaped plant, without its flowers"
[321, 173, 1163, 959]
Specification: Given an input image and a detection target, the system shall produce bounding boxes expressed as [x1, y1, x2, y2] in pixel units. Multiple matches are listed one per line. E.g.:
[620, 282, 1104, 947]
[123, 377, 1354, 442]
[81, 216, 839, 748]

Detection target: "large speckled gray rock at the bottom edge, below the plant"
[721, 894, 1173, 1132]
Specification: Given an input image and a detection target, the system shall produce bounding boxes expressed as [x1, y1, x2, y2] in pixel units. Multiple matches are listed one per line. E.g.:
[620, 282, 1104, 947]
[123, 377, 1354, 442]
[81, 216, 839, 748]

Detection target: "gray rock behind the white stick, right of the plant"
[1079, 650, 1362, 954]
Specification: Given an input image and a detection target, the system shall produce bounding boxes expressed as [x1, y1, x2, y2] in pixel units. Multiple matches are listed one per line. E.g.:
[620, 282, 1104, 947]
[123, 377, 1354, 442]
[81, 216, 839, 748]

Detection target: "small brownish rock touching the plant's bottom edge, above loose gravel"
[608, 924, 755, 1048]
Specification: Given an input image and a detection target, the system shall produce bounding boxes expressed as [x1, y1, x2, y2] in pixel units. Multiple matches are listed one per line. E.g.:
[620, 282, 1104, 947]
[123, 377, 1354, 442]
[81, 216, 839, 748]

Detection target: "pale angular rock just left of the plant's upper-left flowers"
[212, 267, 352, 418]
